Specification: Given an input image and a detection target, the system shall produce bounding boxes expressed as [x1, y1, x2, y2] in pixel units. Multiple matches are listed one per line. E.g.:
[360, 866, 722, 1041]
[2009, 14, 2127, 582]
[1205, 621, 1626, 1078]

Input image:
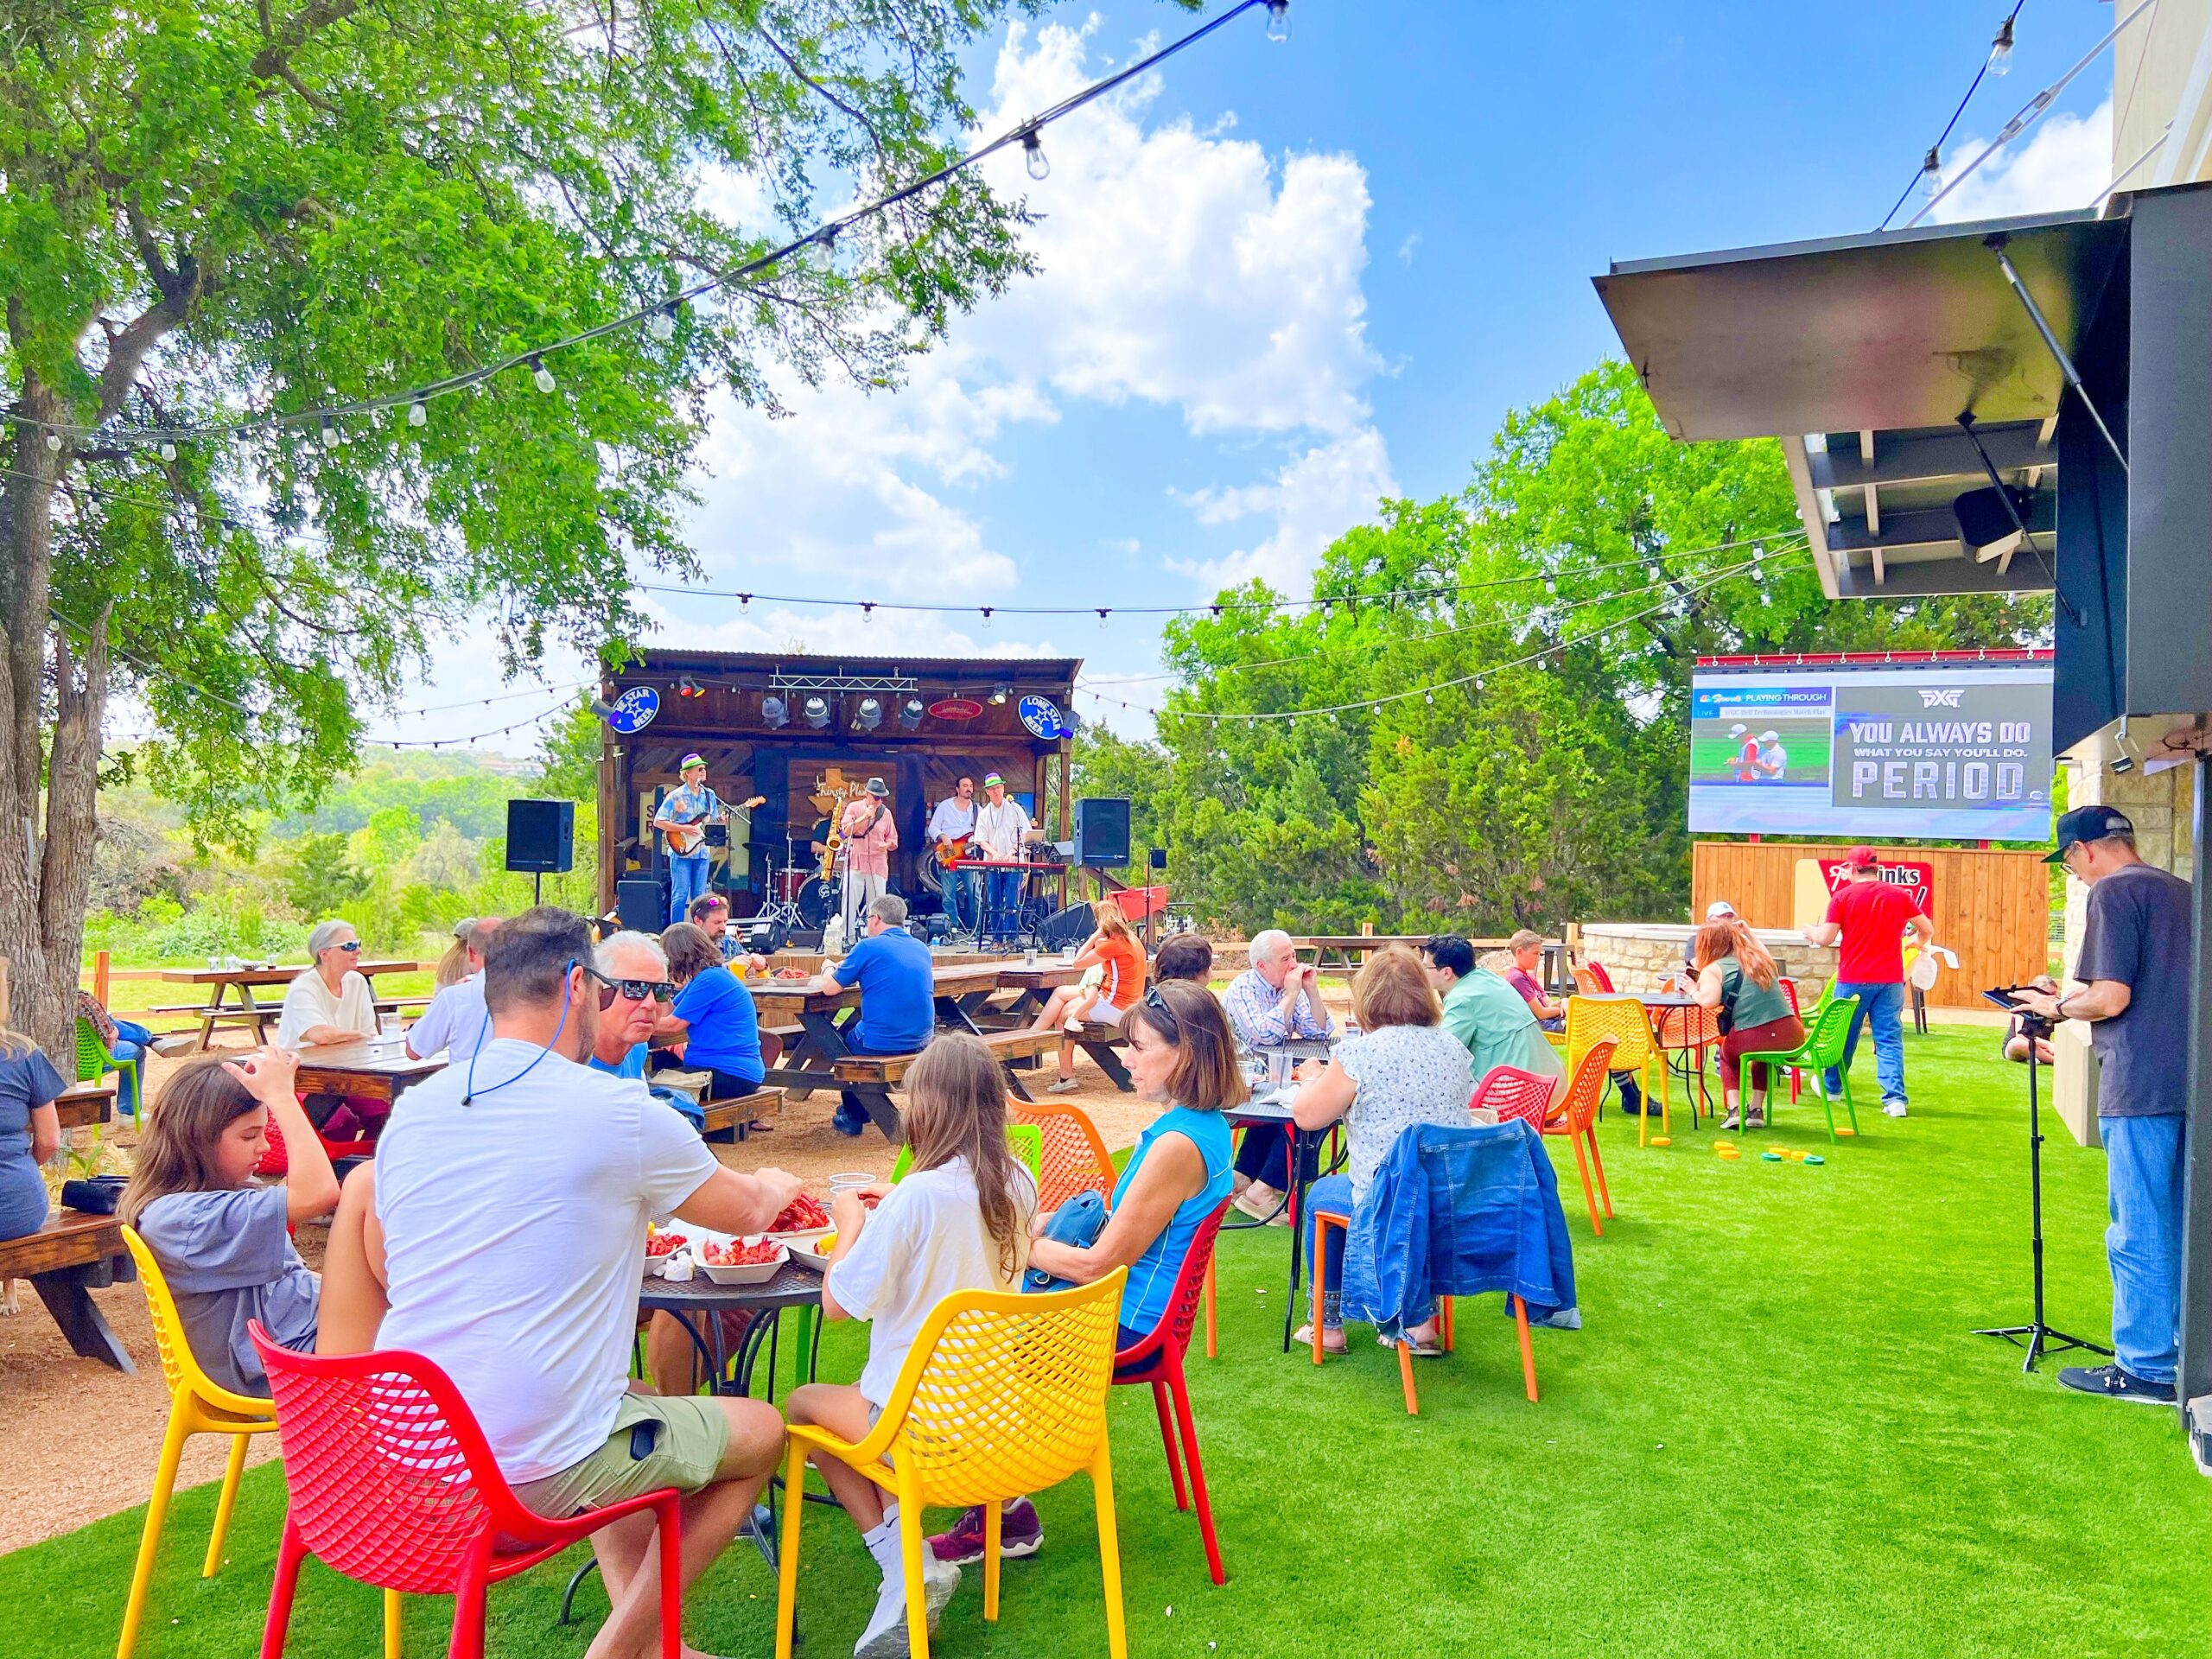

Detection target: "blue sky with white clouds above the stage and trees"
[389, 0, 2114, 752]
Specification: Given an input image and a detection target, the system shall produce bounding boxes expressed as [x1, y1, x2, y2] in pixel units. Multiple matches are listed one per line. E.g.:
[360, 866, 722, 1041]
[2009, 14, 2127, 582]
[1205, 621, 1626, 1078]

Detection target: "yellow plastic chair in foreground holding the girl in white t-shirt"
[777, 1268, 1128, 1659]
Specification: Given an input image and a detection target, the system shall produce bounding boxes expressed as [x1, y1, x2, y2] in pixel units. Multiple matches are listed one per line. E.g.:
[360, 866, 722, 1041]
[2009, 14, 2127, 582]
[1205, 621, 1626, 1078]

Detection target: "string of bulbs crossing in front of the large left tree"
[0, 0, 1287, 449]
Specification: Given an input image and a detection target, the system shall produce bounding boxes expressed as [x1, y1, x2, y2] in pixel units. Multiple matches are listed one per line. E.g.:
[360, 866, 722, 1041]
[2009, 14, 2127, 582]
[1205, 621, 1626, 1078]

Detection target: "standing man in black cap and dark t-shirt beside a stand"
[2019, 807, 2190, 1405]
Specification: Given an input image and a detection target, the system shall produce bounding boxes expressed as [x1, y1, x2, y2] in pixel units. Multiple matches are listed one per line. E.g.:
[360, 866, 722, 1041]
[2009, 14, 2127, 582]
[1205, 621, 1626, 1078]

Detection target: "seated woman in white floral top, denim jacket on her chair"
[1289, 947, 1476, 1358]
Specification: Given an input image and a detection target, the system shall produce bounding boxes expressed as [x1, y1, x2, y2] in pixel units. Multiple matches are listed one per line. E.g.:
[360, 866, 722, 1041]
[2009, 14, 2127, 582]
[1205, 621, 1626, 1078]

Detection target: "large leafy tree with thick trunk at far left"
[0, 0, 1115, 1048]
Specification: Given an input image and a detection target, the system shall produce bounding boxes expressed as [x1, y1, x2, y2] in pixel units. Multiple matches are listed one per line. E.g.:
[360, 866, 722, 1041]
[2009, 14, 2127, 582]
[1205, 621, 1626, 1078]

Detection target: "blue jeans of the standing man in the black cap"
[2097, 1113, 2190, 1382]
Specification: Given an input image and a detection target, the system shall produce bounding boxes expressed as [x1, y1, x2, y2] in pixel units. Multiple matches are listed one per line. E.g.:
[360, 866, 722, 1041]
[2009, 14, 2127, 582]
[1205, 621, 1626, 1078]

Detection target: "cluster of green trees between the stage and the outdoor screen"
[1141, 363, 2049, 936]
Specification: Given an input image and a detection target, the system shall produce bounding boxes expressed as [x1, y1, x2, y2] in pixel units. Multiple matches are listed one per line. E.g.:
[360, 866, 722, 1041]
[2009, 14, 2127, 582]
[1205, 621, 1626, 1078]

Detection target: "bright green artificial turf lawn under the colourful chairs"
[0, 1028, 2212, 1659]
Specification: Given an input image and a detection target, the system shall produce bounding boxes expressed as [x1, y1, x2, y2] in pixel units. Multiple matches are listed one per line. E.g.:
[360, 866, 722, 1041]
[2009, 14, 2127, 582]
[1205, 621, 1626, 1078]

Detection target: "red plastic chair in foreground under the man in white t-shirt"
[245, 1320, 683, 1659]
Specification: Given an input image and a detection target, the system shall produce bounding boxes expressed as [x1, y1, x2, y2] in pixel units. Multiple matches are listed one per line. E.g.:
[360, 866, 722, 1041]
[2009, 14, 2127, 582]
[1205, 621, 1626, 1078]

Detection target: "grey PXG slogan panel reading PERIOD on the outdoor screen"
[1832, 681, 2050, 812]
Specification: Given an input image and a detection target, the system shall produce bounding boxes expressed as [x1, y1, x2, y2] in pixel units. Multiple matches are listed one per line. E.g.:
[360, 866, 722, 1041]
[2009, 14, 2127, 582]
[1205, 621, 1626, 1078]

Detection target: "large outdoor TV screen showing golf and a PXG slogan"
[1690, 664, 2050, 841]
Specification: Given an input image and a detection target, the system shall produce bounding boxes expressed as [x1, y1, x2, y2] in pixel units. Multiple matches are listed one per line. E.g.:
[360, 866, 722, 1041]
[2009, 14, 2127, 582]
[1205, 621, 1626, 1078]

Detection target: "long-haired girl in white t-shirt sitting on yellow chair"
[790, 1033, 1038, 1659]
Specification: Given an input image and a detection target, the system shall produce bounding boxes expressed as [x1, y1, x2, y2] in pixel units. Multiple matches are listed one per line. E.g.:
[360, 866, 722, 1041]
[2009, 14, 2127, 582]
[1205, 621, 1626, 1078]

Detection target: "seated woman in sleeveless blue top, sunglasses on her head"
[929, 980, 1248, 1566]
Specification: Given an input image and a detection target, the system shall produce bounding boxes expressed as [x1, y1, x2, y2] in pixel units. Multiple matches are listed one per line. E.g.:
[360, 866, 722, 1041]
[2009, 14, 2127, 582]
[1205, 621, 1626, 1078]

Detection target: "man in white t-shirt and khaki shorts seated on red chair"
[365, 909, 798, 1659]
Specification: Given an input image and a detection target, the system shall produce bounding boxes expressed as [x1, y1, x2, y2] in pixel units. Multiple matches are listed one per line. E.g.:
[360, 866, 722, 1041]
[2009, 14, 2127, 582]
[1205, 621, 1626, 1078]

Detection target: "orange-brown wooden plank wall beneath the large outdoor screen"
[1690, 841, 2050, 1008]
